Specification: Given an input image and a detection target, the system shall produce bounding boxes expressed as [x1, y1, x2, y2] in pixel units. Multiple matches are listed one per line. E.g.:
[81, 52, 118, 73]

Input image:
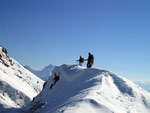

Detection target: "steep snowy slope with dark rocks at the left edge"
[0, 46, 43, 110]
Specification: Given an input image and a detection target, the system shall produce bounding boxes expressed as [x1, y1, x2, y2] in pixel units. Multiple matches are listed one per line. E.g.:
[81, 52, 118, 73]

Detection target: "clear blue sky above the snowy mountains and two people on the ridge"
[0, 0, 150, 80]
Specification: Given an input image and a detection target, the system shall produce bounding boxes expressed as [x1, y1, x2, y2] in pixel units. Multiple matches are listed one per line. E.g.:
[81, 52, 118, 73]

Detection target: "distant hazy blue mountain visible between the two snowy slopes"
[24, 64, 55, 81]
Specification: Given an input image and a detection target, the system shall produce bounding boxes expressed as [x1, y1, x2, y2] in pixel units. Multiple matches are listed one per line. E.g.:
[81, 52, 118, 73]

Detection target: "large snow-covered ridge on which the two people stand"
[24, 65, 150, 113]
